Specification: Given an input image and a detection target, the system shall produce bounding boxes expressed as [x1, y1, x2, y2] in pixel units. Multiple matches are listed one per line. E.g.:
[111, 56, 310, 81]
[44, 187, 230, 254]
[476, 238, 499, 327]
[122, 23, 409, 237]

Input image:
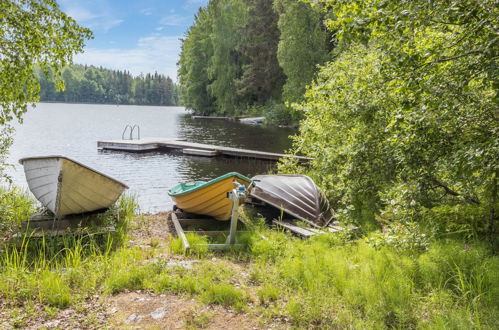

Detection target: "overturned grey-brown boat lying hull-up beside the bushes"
[250, 174, 333, 227]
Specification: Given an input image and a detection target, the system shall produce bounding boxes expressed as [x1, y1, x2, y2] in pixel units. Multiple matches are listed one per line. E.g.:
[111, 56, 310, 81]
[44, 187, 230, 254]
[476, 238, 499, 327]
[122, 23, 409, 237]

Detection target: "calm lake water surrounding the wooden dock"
[8, 103, 295, 212]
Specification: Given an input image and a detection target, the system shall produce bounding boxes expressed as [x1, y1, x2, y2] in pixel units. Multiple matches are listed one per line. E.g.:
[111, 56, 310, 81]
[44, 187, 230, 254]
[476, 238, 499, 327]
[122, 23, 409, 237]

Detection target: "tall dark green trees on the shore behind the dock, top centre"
[178, 0, 335, 122]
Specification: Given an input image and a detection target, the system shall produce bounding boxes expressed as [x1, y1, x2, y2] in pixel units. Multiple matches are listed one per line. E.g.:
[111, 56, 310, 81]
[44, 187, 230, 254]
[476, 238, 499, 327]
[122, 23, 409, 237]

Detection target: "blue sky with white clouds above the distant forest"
[57, 0, 208, 80]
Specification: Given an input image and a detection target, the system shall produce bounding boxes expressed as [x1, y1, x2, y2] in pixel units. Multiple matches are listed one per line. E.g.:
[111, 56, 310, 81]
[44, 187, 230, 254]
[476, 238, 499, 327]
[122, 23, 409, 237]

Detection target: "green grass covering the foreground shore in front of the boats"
[0, 187, 499, 329]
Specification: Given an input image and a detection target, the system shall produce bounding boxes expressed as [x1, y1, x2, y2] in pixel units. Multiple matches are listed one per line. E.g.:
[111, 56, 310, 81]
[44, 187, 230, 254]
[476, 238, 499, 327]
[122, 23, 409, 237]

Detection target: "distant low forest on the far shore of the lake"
[36, 64, 180, 106]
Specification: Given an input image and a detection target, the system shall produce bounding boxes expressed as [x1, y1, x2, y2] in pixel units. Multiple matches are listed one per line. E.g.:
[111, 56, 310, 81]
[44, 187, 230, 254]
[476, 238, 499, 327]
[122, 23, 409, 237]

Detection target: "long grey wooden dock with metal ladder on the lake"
[97, 138, 312, 162]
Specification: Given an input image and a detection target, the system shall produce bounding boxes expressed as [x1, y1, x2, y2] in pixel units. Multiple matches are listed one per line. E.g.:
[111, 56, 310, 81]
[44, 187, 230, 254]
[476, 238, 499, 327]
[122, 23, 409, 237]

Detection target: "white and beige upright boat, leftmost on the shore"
[19, 156, 128, 218]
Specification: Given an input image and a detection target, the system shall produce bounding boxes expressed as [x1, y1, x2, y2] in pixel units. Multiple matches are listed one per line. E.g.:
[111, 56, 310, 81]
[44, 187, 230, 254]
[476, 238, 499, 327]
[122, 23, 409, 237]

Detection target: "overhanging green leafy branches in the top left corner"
[0, 0, 92, 125]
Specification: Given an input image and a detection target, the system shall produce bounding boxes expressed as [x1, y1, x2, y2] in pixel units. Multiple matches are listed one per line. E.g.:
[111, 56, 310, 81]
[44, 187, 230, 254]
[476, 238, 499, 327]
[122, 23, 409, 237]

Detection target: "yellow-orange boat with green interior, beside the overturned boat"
[168, 172, 251, 221]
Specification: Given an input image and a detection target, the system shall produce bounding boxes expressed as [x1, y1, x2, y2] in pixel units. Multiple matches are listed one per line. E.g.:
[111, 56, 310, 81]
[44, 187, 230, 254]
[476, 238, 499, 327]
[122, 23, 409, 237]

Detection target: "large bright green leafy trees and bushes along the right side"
[281, 0, 499, 236]
